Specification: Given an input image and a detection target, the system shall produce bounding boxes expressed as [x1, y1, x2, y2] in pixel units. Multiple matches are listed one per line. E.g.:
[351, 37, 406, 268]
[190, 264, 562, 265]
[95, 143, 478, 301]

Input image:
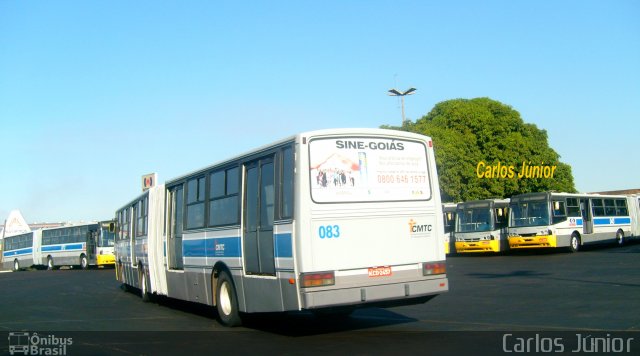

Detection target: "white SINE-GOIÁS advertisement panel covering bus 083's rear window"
[309, 137, 432, 203]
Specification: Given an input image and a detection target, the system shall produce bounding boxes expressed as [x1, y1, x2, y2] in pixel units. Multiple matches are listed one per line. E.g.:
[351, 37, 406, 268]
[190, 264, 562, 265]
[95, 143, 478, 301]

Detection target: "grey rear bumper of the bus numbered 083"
[301, 277, 449, 309]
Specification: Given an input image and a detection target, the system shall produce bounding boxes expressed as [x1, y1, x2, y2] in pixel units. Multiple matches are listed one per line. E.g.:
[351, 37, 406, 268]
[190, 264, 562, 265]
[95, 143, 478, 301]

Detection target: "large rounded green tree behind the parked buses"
[387, 98, 576, 202]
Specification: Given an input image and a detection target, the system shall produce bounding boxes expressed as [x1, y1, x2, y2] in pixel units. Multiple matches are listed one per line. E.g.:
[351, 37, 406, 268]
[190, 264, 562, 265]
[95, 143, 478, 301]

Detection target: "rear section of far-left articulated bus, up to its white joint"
[2, 230, 41, 271]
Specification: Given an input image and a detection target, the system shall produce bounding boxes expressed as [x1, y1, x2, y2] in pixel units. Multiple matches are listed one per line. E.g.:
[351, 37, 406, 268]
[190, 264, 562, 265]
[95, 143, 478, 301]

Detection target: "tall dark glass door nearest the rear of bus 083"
[243, 156, 276, 276]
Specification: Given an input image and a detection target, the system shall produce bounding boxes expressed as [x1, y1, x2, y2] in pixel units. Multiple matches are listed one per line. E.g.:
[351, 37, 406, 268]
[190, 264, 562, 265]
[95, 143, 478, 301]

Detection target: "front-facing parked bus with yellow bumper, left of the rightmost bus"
[455, 199, 509, 253]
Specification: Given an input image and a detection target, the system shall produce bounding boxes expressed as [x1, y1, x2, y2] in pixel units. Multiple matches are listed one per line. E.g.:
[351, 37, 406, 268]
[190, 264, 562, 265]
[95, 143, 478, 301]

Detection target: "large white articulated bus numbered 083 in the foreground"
[116, 129, 448, 326]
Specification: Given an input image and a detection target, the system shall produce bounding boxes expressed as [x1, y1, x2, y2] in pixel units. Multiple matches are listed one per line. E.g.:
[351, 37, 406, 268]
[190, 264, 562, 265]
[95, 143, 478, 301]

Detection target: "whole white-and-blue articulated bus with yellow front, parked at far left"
[2, 221, 115, 271]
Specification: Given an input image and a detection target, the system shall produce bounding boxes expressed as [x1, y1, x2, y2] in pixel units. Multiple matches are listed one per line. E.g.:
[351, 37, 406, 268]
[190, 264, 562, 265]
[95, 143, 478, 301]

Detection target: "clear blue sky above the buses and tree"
[0, 0, 640, 223]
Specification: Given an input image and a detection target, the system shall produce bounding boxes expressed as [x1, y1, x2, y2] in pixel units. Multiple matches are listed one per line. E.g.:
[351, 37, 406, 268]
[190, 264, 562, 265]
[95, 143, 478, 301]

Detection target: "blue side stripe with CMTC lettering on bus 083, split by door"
[182, 233, 293, 257]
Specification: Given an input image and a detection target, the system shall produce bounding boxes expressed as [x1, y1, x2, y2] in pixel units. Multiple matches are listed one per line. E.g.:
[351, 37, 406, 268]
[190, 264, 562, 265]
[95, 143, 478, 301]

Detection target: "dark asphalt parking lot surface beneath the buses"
[0, 241, 640, 354]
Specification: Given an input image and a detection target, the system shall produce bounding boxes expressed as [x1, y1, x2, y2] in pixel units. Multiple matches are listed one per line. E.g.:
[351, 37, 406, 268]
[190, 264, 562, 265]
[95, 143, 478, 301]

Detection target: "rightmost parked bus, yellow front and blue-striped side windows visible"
[509, 192, 638, 252]
